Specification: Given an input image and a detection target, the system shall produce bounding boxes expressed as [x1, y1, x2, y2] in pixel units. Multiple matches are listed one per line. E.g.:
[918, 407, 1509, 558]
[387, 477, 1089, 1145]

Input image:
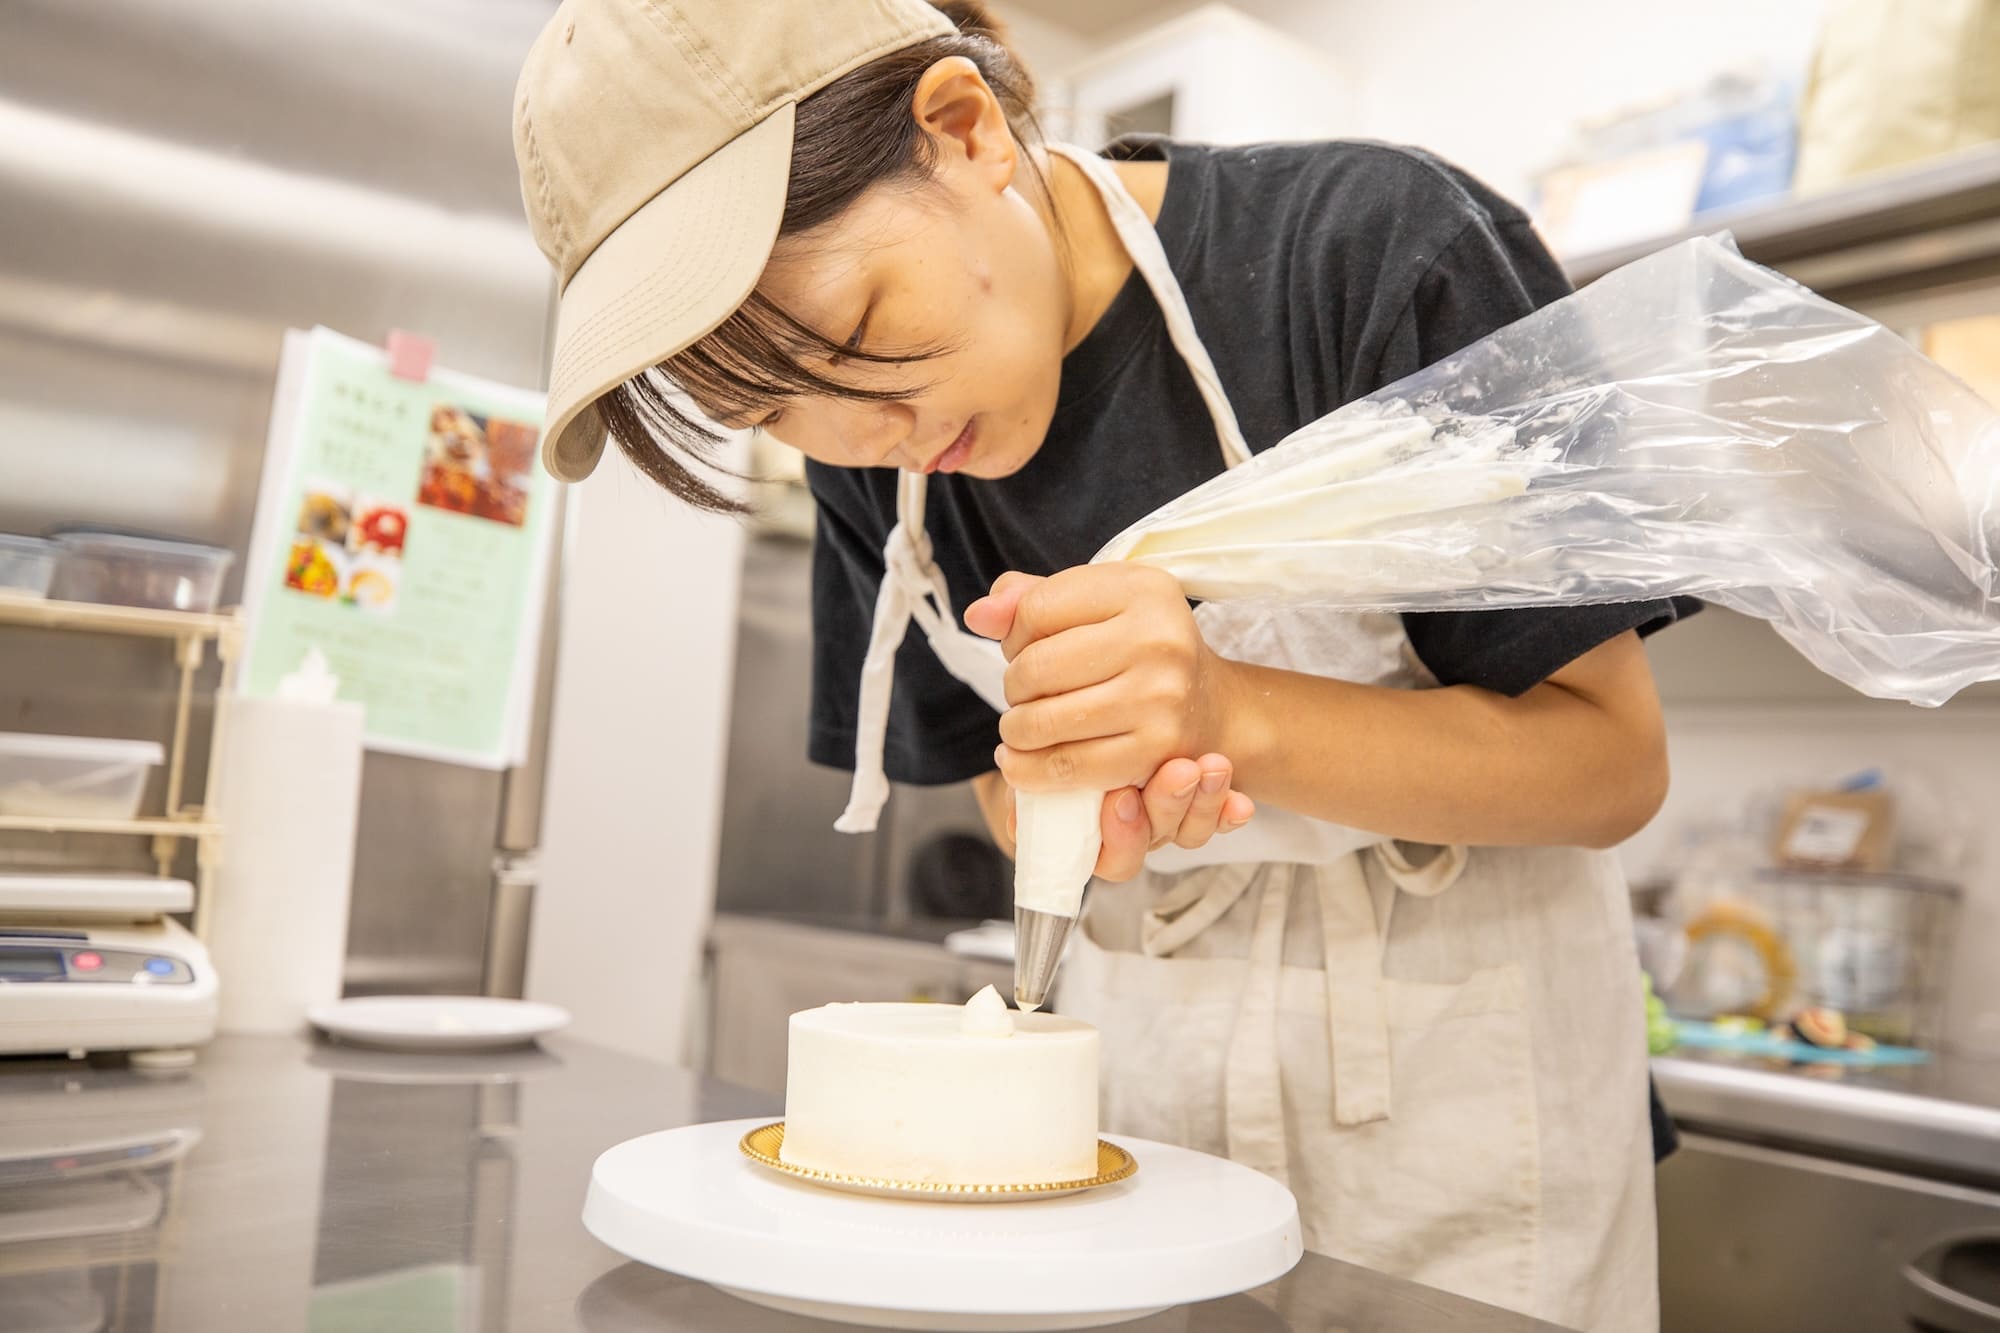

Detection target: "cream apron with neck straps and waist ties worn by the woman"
[838, 146, 1658, 1333]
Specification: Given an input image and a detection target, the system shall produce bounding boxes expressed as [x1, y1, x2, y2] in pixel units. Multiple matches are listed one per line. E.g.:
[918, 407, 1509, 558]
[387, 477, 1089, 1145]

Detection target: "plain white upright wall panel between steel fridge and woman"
[526, 450, 748, 1061]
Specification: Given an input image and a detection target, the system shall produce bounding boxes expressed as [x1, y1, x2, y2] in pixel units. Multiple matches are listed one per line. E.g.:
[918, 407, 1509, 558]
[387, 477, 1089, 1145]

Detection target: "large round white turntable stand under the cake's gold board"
[584, 1121, 1304, 1329]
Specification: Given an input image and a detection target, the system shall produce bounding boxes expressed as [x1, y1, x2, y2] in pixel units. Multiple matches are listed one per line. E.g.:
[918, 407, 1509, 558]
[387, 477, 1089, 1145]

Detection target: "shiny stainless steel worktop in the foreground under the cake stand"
[0, 1037, 1584, 1333]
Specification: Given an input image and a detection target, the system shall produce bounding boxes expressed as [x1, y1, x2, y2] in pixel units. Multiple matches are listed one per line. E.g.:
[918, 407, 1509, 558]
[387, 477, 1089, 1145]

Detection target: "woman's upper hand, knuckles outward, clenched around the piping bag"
[966, 564, 1236, 793]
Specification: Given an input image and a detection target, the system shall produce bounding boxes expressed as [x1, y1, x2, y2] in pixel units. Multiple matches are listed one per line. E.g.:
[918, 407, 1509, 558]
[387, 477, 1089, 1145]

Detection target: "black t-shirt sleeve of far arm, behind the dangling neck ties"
[806, 462, 1000, 787]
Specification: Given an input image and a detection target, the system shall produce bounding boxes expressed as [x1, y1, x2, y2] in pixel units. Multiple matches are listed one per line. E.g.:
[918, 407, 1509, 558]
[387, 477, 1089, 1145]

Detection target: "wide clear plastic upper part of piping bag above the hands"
[1098, 240, 2000, 705]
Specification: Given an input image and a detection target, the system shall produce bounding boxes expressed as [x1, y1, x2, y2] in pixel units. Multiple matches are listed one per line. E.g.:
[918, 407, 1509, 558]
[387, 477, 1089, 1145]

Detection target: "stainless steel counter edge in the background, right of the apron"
[1652, 1051, 2000, 1183]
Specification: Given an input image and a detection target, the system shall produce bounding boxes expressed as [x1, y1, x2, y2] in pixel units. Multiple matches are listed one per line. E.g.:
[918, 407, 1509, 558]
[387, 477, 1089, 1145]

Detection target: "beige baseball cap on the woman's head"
[514, 0, 954, 482]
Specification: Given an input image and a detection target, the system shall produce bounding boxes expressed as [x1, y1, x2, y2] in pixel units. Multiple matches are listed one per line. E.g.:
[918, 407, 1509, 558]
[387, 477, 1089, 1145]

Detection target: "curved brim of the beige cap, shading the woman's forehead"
[542, 102, 796, 482]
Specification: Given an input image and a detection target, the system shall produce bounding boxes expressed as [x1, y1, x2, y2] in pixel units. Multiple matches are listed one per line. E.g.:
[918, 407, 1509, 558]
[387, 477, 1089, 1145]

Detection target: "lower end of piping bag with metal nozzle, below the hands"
[1014, 791, 1104, 1013]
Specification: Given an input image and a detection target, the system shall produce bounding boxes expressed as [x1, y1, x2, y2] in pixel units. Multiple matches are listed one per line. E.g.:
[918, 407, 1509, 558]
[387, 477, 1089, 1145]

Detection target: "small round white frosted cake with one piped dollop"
[778, 987, 1098, 1185]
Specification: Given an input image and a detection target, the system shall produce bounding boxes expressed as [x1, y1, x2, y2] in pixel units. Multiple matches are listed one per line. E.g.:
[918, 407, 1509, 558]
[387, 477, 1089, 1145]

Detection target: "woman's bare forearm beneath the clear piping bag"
[1222, 638, 1666, 847]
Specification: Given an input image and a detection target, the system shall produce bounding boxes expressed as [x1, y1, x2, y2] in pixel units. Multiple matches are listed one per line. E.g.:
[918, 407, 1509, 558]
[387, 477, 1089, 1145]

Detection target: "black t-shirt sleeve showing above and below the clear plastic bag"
[1350, 182, 1700, 695]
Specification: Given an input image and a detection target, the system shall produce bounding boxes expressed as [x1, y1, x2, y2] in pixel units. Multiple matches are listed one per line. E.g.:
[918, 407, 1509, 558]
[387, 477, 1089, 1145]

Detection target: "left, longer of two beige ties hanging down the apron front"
[1222, 865, 1298, 1185]
